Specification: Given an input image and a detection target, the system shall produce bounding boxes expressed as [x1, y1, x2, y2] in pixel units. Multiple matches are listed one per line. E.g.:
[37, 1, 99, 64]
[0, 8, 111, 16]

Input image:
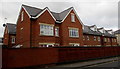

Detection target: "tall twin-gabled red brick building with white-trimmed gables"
[16, 5, 83, 47]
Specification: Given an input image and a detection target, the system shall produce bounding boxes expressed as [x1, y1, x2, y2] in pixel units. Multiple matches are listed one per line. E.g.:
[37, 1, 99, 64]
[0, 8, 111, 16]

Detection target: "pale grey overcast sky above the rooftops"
[0, 0, 119, 37]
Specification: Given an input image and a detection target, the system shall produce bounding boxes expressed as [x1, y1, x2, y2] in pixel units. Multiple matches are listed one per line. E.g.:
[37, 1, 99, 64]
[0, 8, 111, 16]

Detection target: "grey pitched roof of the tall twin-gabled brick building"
[22, 5, 73, 21]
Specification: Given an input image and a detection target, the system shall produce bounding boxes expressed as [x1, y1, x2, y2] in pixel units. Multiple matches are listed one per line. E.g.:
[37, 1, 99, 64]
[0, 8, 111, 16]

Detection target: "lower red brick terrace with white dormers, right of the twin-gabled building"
[83, 25, 117, 46]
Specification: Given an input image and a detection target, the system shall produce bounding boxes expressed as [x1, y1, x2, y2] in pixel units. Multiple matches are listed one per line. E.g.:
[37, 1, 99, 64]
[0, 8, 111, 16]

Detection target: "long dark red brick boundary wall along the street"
[2, 47, 120, 68]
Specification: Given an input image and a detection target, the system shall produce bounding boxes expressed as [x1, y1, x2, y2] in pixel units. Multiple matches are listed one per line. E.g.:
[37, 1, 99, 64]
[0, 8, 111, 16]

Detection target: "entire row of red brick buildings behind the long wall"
[4, 5, 117, 48]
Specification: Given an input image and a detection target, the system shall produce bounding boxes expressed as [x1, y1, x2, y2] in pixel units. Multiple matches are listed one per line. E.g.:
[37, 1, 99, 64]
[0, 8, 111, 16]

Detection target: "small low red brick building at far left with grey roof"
[3, 23, 16, 47]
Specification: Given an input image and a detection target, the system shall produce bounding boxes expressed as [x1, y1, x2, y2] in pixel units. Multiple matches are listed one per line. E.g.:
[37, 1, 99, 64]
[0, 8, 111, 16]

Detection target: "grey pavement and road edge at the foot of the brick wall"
[52, 57, 120, 69]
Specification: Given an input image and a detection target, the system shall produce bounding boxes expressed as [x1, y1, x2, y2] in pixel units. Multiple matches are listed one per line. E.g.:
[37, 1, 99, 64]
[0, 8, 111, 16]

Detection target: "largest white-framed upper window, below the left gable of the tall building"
[40, 24, 54, 36]
